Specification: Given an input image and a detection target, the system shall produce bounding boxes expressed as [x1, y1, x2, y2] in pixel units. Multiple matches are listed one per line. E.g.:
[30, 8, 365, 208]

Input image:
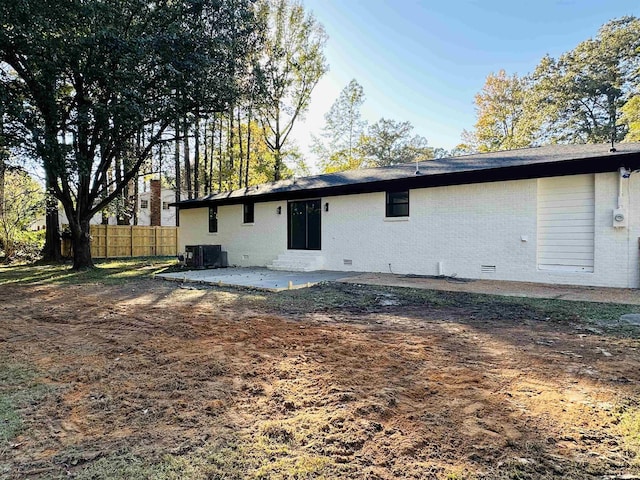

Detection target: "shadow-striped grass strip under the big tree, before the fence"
[0, 257, 178, 285]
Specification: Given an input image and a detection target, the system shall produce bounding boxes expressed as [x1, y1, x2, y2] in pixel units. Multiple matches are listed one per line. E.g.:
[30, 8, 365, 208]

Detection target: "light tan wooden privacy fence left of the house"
[62, 225, 178, 258]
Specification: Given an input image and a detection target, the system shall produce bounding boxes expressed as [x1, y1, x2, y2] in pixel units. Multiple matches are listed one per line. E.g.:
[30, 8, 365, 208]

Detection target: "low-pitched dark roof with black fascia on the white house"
[177, 143, 640, 208]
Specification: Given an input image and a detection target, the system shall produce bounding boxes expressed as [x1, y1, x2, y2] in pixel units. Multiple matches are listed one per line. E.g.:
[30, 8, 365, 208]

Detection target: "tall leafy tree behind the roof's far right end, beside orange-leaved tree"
[531, 17, 640, 143]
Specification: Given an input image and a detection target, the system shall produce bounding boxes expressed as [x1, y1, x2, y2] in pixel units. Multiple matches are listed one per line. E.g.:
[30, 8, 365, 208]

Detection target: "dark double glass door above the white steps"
[287, 199, 321, 250]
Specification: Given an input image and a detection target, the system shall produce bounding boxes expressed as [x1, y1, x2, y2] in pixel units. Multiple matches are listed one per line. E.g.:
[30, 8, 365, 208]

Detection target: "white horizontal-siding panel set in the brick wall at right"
[538, 175, 595, 272]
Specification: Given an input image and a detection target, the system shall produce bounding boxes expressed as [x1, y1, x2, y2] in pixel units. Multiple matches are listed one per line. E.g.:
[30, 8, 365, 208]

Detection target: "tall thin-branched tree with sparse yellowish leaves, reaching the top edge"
[257, 0, 328, 180]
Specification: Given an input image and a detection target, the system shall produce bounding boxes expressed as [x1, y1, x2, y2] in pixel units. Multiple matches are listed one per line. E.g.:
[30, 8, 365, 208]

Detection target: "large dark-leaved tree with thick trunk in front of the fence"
[0, 0, 260, 269]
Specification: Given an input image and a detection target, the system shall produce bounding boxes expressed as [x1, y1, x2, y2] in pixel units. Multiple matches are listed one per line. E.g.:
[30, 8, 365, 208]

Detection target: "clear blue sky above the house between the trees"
[292, 0, 640, 169]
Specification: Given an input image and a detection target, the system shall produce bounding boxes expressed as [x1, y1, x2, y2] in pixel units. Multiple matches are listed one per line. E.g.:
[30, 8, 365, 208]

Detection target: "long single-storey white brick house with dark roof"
[178, 143, 640, 288]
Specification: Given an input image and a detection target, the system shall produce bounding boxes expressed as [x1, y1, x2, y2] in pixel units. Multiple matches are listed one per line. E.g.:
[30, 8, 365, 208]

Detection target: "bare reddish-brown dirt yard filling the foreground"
[0, 270, 640, 480]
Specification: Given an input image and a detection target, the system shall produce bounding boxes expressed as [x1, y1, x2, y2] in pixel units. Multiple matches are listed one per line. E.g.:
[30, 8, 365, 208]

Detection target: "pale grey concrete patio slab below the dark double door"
[156, 267, 354, 292]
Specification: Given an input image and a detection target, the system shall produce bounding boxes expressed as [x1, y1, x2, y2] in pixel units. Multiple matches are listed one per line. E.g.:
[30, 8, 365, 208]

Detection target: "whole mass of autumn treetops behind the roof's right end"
[464, 16, 640, 151]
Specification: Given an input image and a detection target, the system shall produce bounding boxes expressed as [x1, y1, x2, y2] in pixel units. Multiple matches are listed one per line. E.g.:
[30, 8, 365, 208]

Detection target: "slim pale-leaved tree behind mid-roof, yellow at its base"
[312, 79, 366, 172]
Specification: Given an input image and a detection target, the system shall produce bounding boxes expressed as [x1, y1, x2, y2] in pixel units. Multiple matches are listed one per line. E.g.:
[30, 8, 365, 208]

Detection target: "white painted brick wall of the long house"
[179, 173, 640, 288]
